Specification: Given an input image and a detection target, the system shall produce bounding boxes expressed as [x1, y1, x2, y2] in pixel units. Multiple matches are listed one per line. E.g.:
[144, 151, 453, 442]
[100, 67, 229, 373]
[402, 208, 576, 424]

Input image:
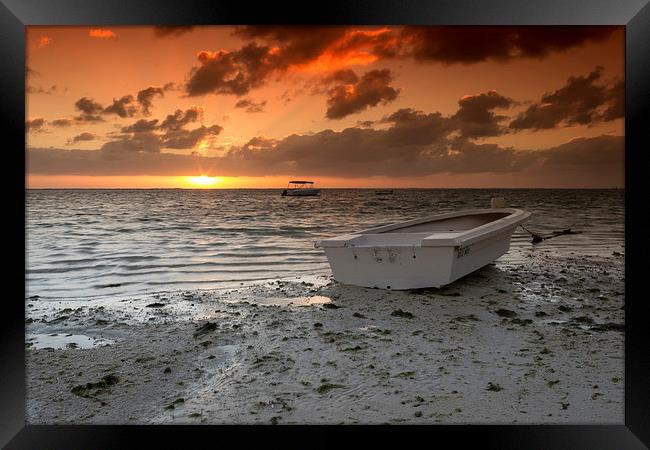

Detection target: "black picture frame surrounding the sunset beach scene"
[0, 0, 650, 449]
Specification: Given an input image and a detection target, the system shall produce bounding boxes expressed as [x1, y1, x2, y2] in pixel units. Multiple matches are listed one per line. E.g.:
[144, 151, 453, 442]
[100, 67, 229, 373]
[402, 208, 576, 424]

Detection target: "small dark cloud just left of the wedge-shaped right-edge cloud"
[451, 91, 513, 138]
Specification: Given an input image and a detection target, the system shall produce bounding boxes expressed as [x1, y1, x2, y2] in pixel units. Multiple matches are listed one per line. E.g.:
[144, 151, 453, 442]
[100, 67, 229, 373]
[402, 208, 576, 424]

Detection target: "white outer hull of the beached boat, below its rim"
[324, 227, 514, 290]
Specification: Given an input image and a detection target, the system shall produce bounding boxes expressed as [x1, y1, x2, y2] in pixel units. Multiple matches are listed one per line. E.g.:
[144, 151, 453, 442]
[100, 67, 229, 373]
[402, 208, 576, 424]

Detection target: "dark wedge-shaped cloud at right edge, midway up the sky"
[510, 67, 624, 130]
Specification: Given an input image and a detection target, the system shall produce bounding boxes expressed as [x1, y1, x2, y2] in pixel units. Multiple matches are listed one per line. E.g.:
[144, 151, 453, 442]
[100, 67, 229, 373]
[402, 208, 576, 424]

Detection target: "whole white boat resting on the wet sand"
[315, 208, 530, 290]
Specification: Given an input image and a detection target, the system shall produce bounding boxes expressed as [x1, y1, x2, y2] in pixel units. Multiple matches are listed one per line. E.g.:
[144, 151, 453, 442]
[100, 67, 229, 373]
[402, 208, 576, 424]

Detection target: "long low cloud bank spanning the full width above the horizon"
[27, 134, 624, 182]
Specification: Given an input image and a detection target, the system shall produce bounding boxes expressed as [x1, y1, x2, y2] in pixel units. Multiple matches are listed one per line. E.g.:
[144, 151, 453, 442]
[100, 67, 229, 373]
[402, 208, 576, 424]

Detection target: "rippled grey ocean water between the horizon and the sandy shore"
[26, 189, 625, 300]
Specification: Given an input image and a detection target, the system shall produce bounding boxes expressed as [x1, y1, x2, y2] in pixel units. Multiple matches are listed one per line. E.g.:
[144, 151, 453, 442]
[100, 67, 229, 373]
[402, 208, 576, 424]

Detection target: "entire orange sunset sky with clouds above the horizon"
[25, 26, 624, 188]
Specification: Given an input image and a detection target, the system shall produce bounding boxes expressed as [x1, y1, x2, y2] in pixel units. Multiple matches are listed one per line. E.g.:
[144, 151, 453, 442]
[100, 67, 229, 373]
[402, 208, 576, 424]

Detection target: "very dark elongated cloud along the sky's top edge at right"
[401, 26, 620, 64]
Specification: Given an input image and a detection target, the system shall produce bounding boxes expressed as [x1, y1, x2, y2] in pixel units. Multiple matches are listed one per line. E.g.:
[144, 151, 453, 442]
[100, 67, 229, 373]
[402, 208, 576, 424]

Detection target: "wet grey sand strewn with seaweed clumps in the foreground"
[26, 253, 625, 424]
